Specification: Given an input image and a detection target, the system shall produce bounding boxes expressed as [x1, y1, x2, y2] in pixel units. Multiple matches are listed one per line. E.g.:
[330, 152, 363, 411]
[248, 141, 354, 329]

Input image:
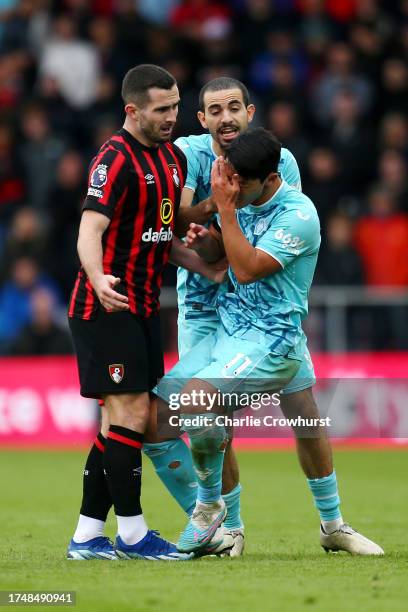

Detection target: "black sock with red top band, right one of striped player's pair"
[103, 425, 143, 520]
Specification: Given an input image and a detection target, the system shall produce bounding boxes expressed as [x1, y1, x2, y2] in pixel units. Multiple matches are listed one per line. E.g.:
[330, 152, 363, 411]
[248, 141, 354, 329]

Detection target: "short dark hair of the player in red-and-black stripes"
[122, 64, 177, 106]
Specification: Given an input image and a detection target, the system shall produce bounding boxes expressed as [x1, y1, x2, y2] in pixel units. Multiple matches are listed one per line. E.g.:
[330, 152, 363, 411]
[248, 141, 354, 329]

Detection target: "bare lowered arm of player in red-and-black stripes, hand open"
[78, 210, 129, 311]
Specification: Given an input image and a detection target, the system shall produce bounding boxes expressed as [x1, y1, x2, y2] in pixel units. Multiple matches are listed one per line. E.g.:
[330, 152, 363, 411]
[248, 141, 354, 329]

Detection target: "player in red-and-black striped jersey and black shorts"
[67, 65, 223, 560]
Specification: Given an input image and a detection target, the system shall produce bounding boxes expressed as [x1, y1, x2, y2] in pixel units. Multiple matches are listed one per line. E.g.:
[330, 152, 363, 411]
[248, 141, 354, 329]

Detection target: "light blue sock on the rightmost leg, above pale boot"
[307, 470, 343, 533]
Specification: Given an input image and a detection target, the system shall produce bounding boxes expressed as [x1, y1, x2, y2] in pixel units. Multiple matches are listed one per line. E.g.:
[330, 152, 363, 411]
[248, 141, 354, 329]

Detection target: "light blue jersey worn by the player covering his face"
[218, 181, 320, 360]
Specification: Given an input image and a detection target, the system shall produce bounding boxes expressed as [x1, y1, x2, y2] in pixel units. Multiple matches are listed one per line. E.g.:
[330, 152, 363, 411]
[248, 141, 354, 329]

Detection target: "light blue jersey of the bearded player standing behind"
[175, 134, 301, 316]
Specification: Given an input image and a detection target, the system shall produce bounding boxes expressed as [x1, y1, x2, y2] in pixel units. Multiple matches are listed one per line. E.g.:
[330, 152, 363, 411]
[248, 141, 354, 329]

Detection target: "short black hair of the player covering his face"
[226, 128, 281, 181]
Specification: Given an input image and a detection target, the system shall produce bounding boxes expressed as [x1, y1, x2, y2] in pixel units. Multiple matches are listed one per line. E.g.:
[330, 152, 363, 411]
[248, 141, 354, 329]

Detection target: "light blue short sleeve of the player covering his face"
[255, 209, 320, 268]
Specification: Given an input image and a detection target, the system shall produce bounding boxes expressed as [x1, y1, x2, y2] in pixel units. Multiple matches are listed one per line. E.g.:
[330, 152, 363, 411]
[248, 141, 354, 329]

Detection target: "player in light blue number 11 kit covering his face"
[153, 128, 383, 555]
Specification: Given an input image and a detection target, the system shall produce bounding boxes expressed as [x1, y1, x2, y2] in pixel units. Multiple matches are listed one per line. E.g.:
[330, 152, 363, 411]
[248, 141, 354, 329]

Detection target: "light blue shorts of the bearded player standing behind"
[178, 308, 316, 395]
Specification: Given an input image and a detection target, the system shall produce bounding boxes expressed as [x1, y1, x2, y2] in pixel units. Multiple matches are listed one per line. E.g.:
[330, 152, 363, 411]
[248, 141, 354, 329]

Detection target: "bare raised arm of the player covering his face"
[211, 159, 282, 285]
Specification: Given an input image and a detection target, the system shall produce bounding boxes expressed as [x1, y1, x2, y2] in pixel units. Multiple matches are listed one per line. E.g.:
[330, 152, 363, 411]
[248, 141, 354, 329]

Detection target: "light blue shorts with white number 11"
[158, 326, 300, 402]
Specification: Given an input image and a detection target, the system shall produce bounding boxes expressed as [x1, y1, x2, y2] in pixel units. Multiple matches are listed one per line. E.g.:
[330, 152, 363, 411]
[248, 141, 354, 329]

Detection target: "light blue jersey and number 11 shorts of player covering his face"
[155, 181, 320, 408]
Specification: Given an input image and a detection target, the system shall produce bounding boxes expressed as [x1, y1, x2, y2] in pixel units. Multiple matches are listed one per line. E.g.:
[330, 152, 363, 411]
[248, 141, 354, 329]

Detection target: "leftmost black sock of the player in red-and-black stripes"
[75, 433, 112, 520]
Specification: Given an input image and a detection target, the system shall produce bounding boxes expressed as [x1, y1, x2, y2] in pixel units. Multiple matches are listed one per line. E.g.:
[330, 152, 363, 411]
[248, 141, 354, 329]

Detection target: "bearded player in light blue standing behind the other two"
[143, 77, 300, 556]
